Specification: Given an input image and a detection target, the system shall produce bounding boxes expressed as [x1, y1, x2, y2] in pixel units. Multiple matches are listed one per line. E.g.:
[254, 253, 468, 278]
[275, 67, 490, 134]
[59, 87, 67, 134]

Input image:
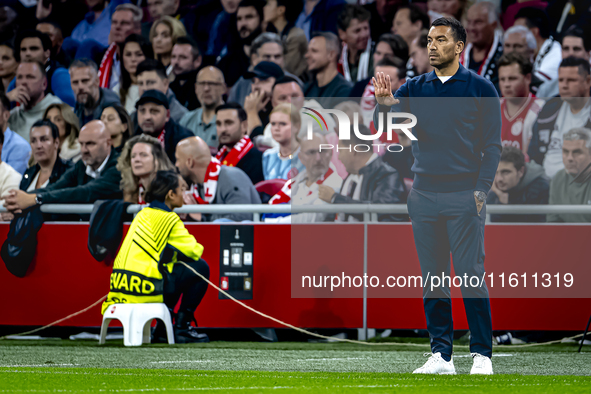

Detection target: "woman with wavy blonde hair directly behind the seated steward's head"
[117, 134, 175, 204]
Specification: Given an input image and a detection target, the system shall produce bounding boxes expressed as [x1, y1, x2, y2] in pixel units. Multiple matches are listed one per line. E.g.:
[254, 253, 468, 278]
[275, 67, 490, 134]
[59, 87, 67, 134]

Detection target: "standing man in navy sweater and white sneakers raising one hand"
[374, 18, 501, 375]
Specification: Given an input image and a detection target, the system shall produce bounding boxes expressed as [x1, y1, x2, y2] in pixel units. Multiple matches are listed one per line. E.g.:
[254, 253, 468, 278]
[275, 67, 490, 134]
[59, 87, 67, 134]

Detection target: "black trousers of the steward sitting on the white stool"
[164, 259, 209, 313]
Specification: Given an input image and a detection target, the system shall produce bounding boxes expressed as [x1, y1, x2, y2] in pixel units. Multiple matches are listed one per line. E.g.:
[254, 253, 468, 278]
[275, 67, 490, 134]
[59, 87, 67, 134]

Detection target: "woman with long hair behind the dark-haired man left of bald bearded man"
[43, 104, 80, 162]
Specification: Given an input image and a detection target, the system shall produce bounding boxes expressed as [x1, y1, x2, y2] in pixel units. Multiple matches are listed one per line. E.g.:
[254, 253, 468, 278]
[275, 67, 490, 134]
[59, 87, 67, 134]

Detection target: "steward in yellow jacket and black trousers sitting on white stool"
[102, 171, 209, 343]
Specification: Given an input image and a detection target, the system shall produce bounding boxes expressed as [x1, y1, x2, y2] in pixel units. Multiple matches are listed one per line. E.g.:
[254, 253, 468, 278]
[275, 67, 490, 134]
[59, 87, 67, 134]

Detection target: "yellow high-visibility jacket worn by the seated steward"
[101, 201, 203, 314]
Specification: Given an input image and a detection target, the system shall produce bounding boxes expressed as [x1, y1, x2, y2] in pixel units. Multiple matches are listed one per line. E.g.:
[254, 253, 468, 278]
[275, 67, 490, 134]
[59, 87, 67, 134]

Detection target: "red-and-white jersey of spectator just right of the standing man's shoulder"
[501, 93, 544, 155]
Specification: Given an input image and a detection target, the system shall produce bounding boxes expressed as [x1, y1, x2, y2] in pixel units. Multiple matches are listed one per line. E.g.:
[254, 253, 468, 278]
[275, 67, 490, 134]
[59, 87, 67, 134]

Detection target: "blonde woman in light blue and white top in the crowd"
[263, 103, 304, 180]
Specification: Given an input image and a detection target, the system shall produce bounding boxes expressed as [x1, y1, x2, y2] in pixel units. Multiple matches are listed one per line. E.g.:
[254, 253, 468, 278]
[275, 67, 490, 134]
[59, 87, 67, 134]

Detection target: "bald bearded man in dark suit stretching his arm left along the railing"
[5, 120, 123, 212]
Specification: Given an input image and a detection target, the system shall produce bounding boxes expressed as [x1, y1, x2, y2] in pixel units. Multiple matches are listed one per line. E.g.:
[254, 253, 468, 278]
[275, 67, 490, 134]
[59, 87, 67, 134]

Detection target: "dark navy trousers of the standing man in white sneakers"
[408, 188, 492, 359]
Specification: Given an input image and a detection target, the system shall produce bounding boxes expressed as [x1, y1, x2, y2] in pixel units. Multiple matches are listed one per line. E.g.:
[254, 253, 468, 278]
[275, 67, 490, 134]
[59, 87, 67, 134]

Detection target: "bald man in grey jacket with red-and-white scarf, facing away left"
[175, 137, 261, 222]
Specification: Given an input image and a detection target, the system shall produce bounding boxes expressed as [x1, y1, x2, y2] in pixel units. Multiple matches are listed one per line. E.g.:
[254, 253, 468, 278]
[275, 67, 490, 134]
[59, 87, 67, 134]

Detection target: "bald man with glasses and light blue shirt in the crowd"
[179, 66, 226, 154]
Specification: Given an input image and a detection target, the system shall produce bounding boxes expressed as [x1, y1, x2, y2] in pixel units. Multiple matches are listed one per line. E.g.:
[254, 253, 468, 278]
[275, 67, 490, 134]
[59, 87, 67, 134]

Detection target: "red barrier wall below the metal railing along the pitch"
[0, 223, 591, 330]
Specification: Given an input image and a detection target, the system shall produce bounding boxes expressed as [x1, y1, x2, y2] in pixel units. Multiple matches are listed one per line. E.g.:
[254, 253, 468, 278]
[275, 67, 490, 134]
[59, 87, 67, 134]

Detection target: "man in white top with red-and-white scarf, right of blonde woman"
[291, 133, 343, 223]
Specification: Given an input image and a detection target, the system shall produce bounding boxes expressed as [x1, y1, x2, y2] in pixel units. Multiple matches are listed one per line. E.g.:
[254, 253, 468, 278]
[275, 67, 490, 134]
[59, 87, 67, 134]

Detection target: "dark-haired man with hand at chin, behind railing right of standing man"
[486, 146, 550, 222]
